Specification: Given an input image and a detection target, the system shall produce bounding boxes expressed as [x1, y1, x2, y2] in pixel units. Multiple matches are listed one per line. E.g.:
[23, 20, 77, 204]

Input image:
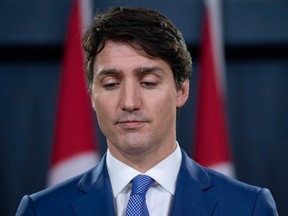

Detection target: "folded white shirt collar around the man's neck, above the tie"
[106, 142, 182, 198]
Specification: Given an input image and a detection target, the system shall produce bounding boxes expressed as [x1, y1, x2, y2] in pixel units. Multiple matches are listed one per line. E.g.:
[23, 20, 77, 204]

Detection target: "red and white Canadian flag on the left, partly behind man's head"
[48, 0, 99, 186]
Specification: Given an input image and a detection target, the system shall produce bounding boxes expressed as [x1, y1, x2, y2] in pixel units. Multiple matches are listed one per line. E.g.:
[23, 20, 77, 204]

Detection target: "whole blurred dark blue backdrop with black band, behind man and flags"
[0, 0, 288, 215]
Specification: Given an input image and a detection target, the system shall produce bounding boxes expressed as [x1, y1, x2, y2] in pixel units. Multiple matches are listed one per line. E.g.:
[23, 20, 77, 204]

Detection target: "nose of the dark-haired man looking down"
[120, 81, 141, 112]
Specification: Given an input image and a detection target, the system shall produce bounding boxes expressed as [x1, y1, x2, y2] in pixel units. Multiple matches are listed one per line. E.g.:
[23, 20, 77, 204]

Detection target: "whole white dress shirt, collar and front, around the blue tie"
[106, 143, 182, 216]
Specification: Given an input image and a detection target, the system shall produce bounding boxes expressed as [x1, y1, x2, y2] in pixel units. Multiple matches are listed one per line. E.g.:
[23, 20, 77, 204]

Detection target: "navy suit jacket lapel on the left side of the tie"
[72, 156, 115, 216]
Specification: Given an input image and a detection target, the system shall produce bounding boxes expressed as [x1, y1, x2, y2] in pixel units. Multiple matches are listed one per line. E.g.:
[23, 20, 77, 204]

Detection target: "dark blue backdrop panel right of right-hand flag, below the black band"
[227, 59, 288, 215]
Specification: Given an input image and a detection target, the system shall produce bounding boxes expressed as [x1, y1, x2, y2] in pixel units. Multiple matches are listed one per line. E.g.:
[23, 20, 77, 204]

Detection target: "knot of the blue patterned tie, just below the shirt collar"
[131, 175, 155, 196]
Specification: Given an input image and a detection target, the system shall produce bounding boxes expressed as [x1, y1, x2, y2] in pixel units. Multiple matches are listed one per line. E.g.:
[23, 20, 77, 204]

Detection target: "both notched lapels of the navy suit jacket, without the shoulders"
[72, 151, 217, 216]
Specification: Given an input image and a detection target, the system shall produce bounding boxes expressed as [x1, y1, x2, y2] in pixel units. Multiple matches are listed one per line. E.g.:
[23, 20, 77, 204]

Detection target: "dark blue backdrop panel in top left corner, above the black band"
[0, 0, 72, 45]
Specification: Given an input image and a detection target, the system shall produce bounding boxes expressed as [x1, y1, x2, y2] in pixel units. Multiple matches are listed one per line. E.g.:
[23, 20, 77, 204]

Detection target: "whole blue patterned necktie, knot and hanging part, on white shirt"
[126, 175, 154, 216]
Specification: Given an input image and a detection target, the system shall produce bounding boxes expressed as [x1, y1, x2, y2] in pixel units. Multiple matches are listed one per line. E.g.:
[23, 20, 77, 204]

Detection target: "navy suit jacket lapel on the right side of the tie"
[171, 151, 217, 216]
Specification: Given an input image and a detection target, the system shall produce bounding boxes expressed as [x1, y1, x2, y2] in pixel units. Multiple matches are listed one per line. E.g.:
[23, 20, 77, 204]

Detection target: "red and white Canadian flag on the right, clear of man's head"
[193, 0, 234, 177]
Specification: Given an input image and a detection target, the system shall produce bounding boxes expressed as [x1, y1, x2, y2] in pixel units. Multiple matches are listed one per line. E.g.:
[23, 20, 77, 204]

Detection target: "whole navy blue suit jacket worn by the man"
[16, 151, 278, 216]
